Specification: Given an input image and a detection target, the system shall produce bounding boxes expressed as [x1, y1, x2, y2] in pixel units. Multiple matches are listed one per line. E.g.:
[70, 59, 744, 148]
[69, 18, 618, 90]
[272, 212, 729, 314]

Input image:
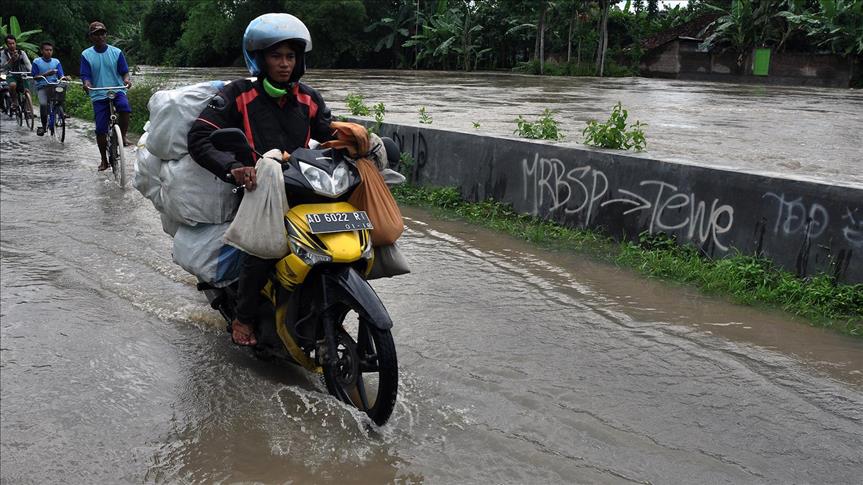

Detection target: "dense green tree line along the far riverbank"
[2, 0, 863, 75]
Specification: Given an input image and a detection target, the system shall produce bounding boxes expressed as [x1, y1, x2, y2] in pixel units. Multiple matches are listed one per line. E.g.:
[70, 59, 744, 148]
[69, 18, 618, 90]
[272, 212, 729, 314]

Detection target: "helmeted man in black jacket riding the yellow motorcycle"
[188, 13, 333, 345]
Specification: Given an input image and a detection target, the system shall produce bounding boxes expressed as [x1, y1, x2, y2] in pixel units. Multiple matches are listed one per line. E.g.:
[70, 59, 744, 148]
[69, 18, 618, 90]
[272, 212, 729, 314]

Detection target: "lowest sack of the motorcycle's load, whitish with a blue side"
[173, 223, 242, 287]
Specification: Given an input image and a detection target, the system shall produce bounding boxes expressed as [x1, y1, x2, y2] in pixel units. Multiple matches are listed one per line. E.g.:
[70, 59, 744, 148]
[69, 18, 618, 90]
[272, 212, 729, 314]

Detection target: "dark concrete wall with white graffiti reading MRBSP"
[381, 124, 863, 283]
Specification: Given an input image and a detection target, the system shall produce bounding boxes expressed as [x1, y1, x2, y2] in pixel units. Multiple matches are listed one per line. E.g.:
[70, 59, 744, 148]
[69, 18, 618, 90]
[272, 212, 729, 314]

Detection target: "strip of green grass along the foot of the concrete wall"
[393, 184, 863, 337]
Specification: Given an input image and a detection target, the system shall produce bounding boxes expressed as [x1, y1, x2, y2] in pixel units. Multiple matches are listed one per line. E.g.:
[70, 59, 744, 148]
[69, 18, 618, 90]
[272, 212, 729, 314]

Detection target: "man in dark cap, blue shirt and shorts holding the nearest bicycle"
[81, 22, 132, 172]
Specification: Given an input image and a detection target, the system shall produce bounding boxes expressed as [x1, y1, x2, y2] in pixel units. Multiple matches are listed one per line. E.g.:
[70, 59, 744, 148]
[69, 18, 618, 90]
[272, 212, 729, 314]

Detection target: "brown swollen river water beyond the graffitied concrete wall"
[140, 67, 863, 188]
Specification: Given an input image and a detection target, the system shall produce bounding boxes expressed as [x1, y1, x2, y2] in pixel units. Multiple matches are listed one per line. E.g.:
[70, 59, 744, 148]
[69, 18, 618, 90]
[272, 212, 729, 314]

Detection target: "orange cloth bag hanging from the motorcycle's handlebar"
[321, 121, 405, 246]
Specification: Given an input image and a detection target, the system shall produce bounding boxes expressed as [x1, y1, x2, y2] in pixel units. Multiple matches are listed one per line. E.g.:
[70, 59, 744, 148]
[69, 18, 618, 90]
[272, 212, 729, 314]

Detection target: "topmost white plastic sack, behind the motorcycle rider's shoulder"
[147, 81, 225, 160]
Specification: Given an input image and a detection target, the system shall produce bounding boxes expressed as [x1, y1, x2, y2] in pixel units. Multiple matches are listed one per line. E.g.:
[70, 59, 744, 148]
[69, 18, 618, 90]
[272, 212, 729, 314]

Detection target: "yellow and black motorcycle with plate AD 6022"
[198, 128, 398, 425]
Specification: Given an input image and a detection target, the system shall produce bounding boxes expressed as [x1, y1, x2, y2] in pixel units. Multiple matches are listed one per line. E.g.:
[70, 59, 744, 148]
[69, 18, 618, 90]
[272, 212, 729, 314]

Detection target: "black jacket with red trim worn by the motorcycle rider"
[188, 79, 334, 182]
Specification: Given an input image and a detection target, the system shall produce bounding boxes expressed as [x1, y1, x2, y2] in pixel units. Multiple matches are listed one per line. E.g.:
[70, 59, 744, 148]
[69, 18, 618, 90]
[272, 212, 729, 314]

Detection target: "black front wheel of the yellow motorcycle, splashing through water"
[323, 312, 398, 426]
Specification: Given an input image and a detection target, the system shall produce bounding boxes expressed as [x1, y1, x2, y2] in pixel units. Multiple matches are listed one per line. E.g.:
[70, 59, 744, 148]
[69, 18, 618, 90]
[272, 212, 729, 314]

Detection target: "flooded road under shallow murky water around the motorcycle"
[0, 112, 863, 484]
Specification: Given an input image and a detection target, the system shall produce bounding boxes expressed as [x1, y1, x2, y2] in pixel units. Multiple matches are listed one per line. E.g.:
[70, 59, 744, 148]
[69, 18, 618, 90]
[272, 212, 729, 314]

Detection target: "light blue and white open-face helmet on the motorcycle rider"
[243, 13, 312, 82]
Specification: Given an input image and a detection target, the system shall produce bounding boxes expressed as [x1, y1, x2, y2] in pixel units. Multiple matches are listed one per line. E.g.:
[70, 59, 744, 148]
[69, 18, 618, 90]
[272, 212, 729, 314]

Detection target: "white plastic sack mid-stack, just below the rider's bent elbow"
[157, 154, 239, 226]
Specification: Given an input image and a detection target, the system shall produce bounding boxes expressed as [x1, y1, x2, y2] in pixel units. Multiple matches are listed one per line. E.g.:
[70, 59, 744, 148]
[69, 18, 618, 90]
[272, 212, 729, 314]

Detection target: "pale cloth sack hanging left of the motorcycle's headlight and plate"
[225, 150, 288, 259]
